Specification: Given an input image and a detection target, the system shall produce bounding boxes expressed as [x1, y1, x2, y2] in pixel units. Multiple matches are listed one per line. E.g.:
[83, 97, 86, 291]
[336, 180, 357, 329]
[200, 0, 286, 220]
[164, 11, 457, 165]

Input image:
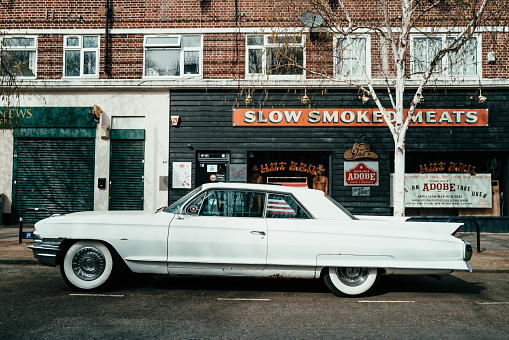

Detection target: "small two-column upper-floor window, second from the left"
[64, 36, 99, 77]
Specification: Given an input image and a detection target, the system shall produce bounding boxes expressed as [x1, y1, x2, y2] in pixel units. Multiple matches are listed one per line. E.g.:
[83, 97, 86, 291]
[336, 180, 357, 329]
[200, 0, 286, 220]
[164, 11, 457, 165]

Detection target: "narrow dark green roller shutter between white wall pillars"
[109, 139, 144, 210]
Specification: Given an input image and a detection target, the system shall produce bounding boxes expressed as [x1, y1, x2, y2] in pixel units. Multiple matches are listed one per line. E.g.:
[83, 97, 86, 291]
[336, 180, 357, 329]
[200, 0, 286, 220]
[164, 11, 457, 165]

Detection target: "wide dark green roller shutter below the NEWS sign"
[13, 138, 95, 223]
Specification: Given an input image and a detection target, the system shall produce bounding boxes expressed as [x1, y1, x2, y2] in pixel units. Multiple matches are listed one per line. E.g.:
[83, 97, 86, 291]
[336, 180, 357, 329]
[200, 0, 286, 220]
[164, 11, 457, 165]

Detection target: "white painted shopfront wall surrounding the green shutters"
[0, 90, 170, 213]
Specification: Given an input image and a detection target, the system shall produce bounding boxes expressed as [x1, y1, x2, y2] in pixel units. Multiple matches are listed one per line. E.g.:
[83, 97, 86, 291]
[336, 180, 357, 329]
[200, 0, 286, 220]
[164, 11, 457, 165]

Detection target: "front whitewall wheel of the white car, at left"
[60, 241, 120, 291]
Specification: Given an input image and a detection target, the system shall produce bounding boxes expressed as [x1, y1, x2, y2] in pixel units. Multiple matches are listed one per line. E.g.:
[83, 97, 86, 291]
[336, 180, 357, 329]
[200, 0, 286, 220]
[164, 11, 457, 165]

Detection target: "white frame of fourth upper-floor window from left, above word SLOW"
[245, 32, 306, 80]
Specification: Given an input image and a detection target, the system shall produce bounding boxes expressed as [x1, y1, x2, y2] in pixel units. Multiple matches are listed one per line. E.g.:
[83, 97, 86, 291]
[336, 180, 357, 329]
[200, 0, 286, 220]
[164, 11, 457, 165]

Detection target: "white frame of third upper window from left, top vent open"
[143, 34, 203, 79]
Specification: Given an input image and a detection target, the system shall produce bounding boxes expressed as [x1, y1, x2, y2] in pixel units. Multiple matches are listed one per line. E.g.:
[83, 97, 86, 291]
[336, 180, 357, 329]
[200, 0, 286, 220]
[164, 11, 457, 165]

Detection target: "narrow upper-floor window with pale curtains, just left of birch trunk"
[334, 35, 371, 78]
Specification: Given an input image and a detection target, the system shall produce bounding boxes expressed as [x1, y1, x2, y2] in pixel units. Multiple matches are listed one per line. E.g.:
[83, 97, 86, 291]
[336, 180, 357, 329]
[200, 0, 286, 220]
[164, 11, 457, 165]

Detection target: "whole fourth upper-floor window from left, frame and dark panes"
[246, 34, 305, 78]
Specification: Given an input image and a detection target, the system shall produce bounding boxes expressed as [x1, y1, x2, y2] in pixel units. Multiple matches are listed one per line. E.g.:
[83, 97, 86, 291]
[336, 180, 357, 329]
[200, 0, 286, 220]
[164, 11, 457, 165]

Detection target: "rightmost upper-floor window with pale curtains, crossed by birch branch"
[411, 34, 481, 77]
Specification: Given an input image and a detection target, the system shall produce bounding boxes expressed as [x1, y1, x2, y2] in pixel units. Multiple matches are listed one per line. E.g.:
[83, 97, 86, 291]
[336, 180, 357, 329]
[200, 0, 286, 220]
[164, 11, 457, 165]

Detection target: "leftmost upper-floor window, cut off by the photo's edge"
[0, 36, 37, 77]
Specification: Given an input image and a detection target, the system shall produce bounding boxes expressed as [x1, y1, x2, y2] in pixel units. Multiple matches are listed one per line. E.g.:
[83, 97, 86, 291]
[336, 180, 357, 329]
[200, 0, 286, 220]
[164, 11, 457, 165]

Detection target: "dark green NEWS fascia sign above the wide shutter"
[0, 107, 97, 129]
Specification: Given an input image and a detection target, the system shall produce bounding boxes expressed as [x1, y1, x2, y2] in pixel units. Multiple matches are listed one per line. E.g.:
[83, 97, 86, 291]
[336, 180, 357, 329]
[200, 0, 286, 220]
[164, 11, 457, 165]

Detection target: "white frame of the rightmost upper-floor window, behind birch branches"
[410, 33, 482, 80]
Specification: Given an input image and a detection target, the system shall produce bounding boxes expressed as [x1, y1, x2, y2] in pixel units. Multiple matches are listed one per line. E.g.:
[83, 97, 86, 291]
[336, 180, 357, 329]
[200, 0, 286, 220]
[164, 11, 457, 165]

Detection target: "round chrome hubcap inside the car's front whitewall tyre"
[72, 247, 106, 281]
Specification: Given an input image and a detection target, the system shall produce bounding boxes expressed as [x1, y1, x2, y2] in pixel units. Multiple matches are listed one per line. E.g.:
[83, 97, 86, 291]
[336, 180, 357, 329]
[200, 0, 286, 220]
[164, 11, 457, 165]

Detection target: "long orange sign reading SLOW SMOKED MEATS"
[233, 108, 488, 127]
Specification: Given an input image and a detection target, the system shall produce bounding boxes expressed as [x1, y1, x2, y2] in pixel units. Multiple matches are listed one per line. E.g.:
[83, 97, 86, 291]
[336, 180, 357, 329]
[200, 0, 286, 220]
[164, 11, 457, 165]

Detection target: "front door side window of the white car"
[199, 190, 265, 217]
